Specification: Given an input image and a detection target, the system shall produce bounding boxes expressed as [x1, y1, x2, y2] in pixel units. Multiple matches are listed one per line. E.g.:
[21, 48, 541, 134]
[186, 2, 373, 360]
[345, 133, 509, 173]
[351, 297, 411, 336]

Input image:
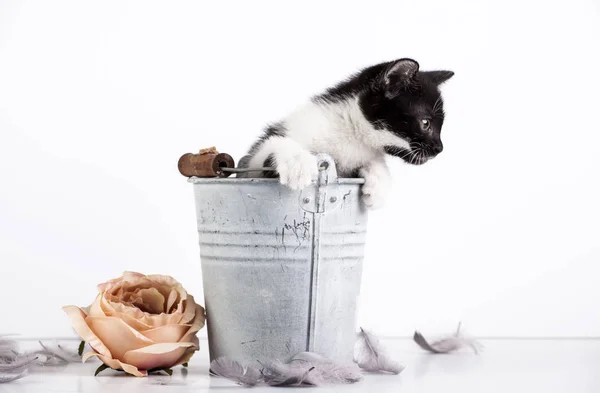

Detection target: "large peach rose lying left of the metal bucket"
[63, 272, 205, 377]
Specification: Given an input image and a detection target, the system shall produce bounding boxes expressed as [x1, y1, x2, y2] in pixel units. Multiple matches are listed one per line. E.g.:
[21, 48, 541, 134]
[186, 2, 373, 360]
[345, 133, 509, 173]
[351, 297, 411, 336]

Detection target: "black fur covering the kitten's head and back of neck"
[313, 59, 454, 164]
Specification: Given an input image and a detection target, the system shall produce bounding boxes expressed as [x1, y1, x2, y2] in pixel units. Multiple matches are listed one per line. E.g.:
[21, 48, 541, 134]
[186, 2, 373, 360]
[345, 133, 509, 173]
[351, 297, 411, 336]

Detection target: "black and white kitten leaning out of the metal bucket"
[244, 59, 454, 208]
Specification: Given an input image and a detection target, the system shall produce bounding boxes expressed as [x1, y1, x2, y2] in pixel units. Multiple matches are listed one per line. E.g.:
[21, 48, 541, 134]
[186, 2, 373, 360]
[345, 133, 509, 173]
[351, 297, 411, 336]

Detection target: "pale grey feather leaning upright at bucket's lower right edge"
[354, 328, 404, 374]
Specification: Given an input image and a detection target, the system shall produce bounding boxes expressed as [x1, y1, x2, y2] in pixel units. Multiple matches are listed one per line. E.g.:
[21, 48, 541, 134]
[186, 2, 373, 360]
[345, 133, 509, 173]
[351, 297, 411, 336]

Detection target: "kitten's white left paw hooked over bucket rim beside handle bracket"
[275, 152, 319, 190]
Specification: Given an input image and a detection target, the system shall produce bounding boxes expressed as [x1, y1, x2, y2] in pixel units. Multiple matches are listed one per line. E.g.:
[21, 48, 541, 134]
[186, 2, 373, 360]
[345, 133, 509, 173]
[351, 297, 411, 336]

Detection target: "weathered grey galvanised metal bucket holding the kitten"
[189, 155, 367, 362]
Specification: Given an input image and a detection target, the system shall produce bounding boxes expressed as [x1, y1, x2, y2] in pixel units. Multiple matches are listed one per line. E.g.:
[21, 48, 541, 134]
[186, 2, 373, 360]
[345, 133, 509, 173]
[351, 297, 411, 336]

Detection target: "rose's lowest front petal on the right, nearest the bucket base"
[123, 343, 194, 370]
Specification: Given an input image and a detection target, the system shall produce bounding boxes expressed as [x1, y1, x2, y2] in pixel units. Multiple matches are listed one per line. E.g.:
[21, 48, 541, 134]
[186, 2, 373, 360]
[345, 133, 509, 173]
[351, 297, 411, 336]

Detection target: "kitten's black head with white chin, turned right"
[360, 59, 454, 165]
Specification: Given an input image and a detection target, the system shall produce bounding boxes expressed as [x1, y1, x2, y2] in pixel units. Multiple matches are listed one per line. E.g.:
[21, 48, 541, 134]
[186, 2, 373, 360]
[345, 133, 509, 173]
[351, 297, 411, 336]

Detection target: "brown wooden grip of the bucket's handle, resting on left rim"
[177, 153, 235, 177]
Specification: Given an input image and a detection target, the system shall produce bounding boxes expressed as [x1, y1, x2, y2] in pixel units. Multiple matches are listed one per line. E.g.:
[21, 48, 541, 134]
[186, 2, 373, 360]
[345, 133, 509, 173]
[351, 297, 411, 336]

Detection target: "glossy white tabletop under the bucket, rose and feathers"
[0, 339, 600, 393]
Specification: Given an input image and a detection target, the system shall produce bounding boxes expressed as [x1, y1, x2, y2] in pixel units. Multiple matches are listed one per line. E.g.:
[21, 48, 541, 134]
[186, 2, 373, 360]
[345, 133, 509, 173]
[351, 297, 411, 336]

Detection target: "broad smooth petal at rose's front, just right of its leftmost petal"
[85, 317, 154, 359]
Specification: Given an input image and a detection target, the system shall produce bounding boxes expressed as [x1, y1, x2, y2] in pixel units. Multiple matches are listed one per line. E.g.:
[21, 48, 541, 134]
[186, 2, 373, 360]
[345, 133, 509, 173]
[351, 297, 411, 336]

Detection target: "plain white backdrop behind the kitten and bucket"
[0, 0, 600, 337]
